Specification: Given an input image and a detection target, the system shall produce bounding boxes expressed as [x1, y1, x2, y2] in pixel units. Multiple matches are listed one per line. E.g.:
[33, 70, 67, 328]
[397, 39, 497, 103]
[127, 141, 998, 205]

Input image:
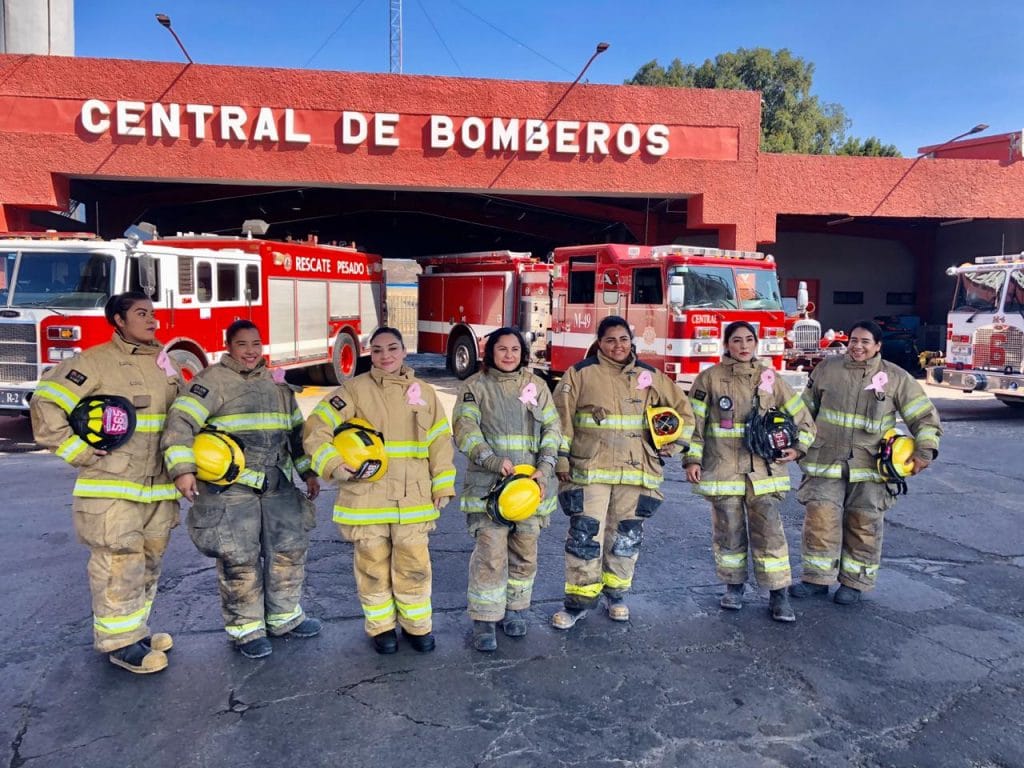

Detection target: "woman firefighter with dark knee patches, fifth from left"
[551, 315, 693, 630]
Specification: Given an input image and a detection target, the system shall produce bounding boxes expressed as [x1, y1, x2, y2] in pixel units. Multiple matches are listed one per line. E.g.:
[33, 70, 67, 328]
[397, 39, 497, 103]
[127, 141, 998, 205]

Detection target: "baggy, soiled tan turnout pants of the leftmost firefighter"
[73, 497, 178, 653]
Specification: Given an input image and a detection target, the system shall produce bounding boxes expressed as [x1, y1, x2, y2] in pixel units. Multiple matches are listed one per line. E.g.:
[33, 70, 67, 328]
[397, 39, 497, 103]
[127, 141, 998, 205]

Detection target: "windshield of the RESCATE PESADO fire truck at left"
[0, 251, 114, 308]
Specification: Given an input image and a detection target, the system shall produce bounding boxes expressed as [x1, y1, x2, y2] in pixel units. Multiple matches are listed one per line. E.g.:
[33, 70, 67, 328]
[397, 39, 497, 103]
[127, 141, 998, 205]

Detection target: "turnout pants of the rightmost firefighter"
[797, 477, 896, 592]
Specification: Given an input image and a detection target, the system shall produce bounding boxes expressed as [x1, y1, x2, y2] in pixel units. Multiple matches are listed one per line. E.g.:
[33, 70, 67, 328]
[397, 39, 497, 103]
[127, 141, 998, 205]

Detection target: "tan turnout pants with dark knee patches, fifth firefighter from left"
[558, 483, 662, 610]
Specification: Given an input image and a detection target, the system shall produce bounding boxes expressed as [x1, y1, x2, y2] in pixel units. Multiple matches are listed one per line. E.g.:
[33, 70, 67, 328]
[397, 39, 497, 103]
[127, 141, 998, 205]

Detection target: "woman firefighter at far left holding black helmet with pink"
[32, 292, 183, 674]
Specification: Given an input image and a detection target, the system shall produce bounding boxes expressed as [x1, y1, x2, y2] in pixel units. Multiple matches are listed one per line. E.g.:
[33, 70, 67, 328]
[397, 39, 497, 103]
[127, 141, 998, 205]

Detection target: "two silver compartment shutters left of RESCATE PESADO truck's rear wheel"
[267, 278, 329, 365]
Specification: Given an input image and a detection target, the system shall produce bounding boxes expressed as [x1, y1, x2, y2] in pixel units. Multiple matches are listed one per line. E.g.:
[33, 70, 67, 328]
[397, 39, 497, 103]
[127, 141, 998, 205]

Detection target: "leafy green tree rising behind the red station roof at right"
[626, 48, 899, 157]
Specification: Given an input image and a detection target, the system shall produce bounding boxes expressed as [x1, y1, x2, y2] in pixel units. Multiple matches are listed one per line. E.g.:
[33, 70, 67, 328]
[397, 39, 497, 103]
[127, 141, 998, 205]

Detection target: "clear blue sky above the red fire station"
[75, 0, 1024, 157]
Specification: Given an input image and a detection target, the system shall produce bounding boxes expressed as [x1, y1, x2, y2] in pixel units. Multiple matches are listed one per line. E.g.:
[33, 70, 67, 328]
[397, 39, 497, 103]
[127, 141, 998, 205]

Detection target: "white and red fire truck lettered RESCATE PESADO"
[0, 232, 386, 415]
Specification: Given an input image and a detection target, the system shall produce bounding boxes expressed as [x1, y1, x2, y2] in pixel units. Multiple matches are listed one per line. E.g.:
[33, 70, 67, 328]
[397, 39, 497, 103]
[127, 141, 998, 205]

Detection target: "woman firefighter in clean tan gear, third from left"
[304, 327, 455, 653]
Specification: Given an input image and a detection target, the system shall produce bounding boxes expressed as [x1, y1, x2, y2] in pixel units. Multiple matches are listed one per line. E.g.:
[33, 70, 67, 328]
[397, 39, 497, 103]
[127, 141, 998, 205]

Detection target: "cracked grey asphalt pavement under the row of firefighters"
[0, 366, 1024, 768]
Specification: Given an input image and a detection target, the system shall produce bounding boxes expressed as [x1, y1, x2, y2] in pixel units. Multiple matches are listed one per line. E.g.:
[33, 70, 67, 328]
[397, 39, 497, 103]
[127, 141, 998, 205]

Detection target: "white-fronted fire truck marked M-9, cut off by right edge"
[927, 253, 1024, 407]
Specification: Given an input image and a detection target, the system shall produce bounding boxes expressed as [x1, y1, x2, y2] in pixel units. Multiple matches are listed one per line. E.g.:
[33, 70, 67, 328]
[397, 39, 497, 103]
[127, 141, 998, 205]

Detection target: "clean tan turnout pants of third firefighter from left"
[338, 520, 436, 637]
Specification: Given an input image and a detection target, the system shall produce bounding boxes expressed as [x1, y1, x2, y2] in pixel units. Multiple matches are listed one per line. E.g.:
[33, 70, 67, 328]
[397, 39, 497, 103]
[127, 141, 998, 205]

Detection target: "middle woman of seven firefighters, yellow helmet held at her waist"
[453, 328, 562, 651]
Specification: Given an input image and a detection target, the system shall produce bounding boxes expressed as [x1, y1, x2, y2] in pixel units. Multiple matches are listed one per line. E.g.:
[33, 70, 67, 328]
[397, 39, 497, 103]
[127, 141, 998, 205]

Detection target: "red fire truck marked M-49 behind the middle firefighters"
[418, 244, 806, 386]
